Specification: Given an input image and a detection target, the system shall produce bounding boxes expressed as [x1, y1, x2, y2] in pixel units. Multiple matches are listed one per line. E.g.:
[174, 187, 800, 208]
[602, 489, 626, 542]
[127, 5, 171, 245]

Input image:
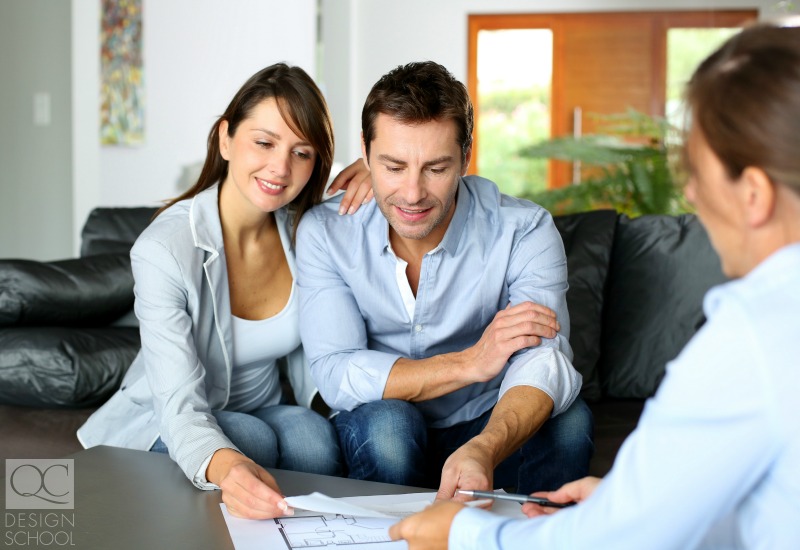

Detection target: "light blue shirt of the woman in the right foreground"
[449, 244, 800, 550]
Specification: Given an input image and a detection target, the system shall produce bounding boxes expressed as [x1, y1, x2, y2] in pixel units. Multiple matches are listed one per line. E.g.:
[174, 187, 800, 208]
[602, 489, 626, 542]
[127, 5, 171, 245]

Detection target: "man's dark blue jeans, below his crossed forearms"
[333, 398, 594, 494]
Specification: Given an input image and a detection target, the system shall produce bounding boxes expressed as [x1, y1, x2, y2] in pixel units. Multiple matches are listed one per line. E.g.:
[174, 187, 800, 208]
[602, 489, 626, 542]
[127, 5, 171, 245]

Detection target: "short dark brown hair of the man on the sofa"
[361, 61, 473, 164]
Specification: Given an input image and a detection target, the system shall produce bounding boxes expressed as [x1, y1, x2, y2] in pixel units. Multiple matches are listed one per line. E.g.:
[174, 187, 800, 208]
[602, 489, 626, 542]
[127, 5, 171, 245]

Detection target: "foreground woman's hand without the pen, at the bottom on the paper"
[389, 501, 464, 550]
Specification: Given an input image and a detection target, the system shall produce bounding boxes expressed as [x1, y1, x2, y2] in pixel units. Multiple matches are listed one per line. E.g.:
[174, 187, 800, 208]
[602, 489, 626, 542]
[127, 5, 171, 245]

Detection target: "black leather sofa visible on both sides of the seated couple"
[0, 208, 725, 475]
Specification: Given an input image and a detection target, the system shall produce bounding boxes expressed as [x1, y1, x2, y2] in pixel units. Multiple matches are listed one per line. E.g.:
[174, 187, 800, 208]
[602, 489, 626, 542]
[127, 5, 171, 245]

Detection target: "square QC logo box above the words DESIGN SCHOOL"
[6, 458, 75, 510]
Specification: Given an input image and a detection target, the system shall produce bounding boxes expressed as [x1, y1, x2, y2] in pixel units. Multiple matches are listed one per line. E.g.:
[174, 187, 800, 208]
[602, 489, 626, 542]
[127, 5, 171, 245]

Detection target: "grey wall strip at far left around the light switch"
[0, 0, 73, 260]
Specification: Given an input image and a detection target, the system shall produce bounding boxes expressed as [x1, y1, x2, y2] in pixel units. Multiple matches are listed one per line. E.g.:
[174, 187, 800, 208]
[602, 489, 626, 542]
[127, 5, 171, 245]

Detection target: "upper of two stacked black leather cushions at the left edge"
[0, 254, 133, 326]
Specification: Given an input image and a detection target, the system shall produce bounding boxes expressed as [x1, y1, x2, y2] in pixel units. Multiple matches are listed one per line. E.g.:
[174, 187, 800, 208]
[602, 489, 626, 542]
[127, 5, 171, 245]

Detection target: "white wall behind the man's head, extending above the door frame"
[322, 0, 778, 166]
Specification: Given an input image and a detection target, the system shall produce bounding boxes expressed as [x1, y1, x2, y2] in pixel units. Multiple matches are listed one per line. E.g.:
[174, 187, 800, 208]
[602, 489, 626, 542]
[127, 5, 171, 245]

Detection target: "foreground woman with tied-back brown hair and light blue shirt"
[391, 21, 800, 550]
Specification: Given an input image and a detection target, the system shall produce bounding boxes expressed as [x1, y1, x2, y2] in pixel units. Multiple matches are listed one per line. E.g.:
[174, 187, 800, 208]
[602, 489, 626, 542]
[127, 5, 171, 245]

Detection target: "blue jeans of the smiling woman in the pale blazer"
[150, 405, 342, 475]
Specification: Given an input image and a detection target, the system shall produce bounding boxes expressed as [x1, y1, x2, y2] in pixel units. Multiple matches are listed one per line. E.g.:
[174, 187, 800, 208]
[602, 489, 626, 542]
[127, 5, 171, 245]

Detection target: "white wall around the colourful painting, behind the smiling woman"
[72, 0, 317, 252]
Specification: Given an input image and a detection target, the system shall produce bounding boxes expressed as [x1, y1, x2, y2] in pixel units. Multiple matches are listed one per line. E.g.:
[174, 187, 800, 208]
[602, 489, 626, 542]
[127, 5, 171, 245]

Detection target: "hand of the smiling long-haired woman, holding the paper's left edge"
[206, 449, 293, 519]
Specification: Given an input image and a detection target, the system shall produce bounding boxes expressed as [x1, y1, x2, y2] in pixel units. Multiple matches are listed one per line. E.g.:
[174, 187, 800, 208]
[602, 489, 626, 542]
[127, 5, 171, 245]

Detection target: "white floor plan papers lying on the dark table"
[220, 493, 525, 550]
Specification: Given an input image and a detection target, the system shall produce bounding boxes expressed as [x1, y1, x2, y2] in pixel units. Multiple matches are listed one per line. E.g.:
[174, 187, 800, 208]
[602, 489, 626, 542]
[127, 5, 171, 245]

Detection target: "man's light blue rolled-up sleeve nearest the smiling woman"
[297, 212, 400, 411]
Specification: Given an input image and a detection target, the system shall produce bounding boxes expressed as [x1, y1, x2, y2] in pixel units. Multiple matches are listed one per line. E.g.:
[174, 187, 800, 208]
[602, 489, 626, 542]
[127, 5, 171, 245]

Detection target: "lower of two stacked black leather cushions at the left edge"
[0, 327, 139, 407]
